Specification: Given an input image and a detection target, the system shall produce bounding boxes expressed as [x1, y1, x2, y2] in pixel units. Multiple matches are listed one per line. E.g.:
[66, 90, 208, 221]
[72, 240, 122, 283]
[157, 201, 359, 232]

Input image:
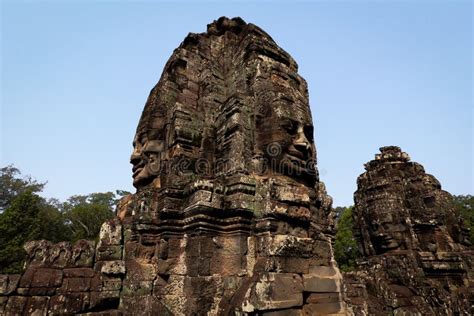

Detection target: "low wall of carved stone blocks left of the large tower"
[0, 220, 125, 315]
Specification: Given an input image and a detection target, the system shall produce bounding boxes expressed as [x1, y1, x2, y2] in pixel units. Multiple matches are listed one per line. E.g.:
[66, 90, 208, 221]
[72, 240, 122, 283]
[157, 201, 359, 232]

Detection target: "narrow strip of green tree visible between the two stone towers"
[334, 207, 360, 271]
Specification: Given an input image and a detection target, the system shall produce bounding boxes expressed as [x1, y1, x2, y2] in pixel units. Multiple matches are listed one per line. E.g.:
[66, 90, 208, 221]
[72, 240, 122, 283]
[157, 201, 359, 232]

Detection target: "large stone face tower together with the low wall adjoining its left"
[0, 18, 348, 315]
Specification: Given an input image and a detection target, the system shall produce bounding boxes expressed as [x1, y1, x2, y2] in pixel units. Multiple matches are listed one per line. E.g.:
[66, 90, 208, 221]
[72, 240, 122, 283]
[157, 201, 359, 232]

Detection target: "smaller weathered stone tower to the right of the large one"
[344, 146, 474, 315]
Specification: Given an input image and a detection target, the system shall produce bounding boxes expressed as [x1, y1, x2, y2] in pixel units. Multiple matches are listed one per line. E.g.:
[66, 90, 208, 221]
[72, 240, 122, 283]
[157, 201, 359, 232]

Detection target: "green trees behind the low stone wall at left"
[0, 166, 129, 274]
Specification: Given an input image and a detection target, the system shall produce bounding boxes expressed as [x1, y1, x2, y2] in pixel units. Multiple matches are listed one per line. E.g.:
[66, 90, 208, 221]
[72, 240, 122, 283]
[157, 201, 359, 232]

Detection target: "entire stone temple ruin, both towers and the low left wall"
[0, 18, 473, 316]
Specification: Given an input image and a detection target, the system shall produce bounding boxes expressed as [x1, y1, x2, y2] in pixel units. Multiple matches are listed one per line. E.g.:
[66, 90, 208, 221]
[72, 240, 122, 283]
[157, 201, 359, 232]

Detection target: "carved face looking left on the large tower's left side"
[130, 134, 165, 188]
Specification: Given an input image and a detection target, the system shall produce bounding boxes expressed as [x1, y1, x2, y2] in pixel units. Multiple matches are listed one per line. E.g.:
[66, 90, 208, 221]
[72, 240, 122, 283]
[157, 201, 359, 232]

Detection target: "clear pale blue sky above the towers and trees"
[0, 1, 473, 206]
